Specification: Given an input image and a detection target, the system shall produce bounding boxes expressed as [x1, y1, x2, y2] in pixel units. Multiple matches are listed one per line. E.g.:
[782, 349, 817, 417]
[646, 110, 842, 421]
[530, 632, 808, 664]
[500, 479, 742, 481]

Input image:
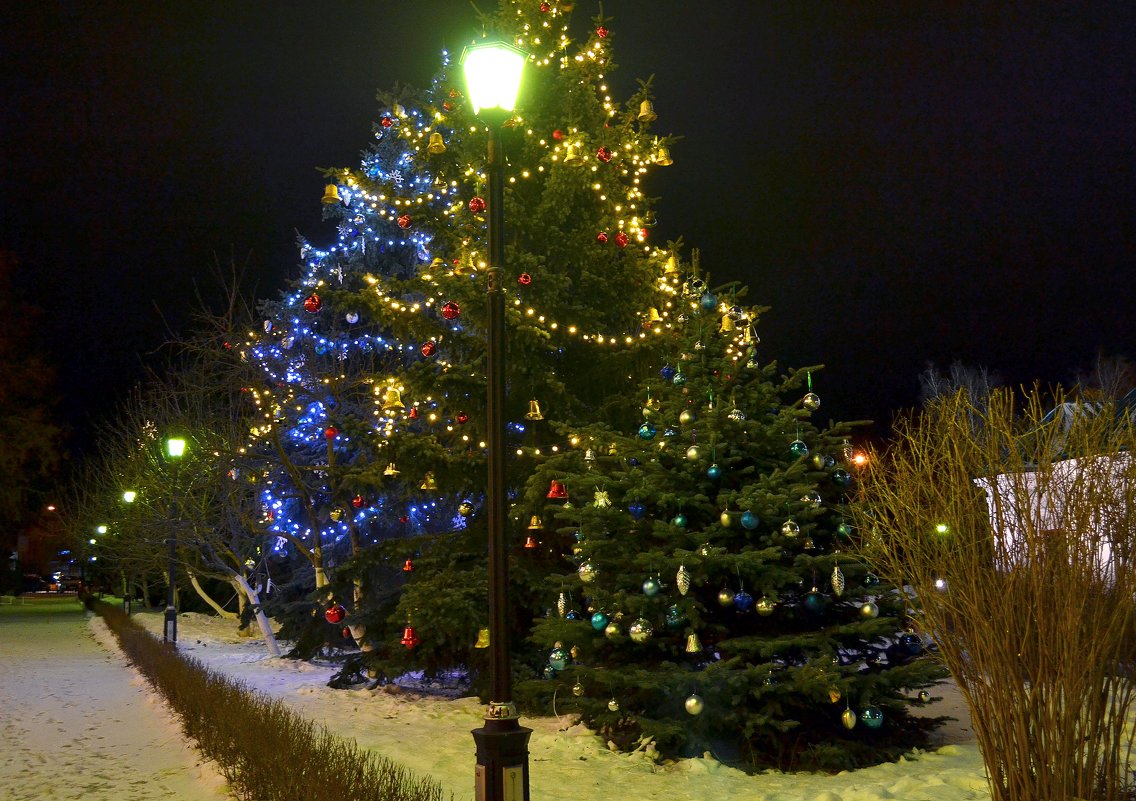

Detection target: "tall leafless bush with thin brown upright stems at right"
[855, 391, 1136, 801]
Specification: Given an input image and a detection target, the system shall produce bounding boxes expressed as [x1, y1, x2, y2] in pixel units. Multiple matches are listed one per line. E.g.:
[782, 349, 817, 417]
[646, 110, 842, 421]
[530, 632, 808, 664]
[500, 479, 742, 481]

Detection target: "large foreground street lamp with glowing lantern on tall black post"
[461, 42, 533, 801]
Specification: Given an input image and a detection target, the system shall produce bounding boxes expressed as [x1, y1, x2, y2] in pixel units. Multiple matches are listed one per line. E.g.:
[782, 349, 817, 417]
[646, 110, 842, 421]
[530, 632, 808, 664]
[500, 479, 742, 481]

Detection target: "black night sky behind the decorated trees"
[0, 0, 1136, 443]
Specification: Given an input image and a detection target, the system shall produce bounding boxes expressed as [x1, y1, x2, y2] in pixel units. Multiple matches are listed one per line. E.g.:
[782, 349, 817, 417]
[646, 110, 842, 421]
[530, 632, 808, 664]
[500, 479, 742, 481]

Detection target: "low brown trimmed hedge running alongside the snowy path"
[84, 596, 452, 801]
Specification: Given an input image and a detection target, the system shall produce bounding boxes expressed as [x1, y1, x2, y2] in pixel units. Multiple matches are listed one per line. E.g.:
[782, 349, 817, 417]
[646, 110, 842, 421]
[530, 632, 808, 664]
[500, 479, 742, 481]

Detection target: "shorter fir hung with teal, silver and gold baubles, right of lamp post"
[521, 274, 942, 769]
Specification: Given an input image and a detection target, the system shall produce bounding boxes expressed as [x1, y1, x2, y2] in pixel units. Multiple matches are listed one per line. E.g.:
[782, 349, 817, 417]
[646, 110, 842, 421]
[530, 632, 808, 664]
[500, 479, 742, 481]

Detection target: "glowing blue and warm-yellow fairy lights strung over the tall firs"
[243, 5, 753, 546]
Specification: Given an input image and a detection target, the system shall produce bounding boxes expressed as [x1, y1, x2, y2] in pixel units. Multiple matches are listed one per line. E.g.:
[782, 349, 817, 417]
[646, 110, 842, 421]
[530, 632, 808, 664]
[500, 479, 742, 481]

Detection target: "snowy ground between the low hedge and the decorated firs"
[128, 614, 991, 801]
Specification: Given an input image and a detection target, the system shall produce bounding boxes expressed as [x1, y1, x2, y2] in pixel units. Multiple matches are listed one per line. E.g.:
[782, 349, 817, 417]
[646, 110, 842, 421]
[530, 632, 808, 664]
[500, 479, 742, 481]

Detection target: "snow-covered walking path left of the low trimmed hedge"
[0, 598, 229, 801]
